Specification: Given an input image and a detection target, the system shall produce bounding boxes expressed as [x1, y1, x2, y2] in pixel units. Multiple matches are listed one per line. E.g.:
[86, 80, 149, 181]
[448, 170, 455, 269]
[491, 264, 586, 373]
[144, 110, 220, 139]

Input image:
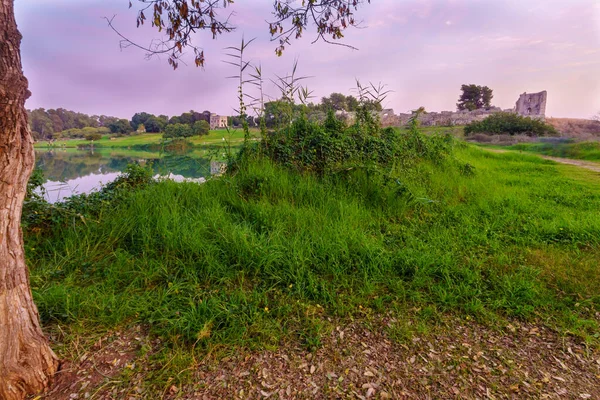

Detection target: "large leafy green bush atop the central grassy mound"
[240, 111, 453, 176]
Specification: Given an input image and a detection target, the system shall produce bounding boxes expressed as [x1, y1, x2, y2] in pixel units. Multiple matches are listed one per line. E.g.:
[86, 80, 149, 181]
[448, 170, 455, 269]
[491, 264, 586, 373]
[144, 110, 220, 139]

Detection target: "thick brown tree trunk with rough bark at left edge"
[0, 0, 58, 400]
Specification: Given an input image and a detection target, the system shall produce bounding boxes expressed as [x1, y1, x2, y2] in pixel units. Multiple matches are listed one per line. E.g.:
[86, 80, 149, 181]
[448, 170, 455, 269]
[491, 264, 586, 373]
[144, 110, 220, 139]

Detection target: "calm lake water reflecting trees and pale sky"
[35, 149, 221, 203]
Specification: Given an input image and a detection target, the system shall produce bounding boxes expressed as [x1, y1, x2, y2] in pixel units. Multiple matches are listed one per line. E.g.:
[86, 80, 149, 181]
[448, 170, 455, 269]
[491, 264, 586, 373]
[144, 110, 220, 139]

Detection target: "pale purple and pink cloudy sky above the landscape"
[15, 0, 600, 118]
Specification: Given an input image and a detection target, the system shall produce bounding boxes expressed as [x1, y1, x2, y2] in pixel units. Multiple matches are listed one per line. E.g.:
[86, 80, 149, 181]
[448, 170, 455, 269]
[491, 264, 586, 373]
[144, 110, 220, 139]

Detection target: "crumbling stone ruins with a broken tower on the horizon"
[378, 90, 547, 126]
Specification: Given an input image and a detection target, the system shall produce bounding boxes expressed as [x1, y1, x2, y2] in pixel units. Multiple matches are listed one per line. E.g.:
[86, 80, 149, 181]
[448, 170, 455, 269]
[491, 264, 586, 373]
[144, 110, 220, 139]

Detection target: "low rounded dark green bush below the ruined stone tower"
[465, 112, 558, 136]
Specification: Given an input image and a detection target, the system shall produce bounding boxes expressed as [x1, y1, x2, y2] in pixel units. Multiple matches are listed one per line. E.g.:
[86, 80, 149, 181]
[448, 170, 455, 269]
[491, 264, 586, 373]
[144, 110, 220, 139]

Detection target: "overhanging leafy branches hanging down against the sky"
[108, 0, 371, 69]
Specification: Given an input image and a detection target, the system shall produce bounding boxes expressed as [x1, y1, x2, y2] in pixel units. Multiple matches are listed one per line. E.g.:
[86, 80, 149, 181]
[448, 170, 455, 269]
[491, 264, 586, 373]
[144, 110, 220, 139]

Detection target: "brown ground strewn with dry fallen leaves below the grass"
[41, 318, 600, 399]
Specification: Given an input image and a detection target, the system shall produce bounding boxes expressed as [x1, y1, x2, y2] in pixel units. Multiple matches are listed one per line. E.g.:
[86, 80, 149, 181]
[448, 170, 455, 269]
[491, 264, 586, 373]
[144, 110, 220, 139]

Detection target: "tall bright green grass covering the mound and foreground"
[26, 146, 600, 354]
